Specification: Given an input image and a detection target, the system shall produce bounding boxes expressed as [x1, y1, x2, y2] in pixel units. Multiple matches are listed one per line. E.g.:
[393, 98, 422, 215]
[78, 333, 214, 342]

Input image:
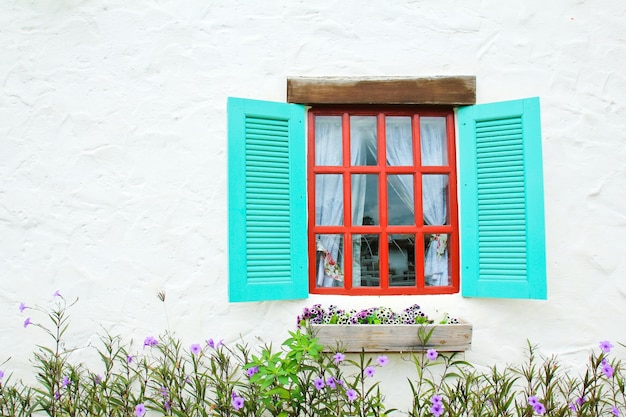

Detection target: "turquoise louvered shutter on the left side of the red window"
[228, 98, 308, 301]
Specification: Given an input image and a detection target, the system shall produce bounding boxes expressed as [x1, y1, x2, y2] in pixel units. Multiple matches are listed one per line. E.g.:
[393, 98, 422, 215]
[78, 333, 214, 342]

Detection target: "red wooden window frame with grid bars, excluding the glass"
[307, 106, 459, 295]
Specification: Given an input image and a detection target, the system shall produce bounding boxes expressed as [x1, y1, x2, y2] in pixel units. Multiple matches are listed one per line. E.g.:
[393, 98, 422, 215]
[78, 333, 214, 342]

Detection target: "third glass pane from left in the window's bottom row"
[389, 234, 415, 287]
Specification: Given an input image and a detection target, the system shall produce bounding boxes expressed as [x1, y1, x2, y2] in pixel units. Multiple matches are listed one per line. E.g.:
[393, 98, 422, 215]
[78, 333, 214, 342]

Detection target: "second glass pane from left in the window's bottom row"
[352, 235, 380, 287]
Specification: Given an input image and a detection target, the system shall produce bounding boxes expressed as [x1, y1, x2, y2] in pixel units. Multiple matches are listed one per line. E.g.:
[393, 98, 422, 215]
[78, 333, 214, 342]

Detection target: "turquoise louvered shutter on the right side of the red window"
[458, 98, 546, 299]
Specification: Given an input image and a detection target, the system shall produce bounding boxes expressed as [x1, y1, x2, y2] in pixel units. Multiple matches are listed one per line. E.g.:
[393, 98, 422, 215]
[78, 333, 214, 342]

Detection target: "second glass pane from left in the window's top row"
[350, 116, 378, 166]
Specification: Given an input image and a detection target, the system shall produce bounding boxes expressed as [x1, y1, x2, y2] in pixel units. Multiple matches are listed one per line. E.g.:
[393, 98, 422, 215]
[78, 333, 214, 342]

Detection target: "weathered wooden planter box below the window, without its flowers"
[311, 322, 472, 352]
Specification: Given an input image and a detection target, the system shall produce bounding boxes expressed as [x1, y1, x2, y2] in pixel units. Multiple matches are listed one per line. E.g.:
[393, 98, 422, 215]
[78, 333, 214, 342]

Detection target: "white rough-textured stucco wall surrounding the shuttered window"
[0, 0, 626, 410]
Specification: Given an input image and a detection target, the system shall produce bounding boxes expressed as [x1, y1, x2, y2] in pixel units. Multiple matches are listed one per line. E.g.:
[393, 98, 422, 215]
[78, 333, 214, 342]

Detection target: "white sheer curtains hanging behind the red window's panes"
[315, 116, 449, 287]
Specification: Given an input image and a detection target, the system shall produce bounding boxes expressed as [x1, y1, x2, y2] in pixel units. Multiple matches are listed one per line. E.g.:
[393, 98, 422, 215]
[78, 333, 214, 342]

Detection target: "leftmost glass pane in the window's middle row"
[315, 174, 343, 226]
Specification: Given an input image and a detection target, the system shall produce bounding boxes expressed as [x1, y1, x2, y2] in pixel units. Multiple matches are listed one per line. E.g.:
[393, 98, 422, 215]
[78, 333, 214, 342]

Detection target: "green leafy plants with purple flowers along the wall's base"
[0, 297, 626, 417]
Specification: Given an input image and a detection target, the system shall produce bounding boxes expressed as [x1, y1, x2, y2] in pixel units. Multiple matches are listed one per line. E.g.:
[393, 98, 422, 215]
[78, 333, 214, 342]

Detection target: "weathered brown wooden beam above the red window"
[287, 76, 476, 106]
